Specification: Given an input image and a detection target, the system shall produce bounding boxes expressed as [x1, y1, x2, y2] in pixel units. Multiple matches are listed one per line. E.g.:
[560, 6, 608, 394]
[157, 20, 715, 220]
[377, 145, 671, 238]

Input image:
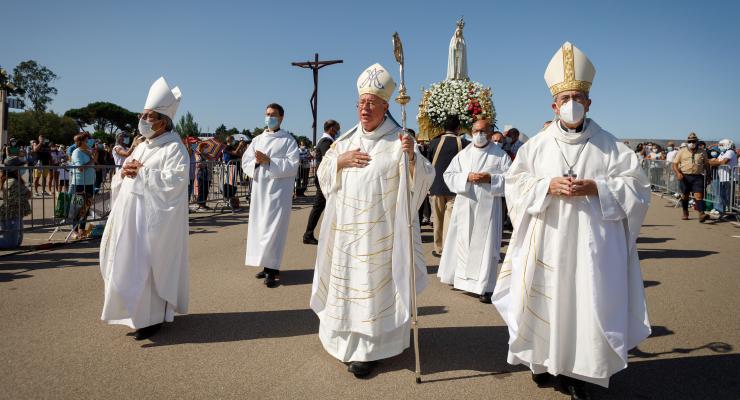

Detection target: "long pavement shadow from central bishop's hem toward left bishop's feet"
[142, 309, 319, 347]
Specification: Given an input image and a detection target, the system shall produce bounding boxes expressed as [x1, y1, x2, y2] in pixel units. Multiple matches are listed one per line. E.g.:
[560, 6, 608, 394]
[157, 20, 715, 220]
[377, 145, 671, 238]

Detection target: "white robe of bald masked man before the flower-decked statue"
[437, 143, 511, 294]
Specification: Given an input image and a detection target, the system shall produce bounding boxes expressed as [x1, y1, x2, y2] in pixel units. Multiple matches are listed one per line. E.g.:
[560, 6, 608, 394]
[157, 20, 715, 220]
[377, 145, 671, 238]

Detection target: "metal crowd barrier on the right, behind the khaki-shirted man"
[642, 160, 740, 220]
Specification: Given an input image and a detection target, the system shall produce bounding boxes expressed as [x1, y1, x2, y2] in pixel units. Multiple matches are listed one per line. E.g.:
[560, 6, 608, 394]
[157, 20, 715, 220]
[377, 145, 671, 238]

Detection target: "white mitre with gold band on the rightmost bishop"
[545, 42, 596, 96]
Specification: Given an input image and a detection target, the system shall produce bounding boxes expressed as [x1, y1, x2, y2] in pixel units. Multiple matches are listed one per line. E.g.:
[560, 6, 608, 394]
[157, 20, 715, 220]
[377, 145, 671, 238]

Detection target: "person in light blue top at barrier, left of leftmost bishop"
[69, 133, 95, 238]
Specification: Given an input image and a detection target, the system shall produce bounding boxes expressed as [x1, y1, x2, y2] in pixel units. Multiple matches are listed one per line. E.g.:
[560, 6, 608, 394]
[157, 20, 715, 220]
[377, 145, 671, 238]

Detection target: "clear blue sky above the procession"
[5, 0, 740, 142]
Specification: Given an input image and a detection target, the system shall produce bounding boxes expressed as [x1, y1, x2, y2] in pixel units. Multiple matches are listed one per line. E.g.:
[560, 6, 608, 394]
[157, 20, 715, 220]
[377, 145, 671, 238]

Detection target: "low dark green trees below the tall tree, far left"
[8, 111, 79, 145]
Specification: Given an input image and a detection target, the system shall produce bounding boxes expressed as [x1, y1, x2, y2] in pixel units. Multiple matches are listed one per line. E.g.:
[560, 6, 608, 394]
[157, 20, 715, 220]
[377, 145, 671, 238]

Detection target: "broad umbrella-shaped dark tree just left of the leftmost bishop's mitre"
[64, 101, 139, 136]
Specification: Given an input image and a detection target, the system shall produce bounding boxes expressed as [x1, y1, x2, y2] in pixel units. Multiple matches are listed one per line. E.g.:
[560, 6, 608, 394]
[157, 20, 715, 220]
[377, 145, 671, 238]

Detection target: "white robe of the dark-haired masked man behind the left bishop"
[242, 130, 300, 269]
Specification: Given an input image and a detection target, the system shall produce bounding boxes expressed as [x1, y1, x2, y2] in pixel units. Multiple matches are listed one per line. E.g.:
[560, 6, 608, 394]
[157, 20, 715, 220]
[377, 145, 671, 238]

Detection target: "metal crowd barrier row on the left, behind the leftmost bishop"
[0, 160, 314, 247]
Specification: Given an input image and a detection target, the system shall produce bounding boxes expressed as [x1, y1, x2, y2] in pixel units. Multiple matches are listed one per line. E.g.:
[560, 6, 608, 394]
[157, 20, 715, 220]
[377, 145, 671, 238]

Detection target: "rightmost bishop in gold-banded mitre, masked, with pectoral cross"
[492, 42, 650, 399]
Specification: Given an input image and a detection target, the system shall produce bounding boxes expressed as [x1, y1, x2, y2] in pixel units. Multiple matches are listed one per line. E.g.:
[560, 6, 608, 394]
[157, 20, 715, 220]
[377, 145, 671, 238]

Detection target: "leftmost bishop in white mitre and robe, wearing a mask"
[100, 78, 190, 340]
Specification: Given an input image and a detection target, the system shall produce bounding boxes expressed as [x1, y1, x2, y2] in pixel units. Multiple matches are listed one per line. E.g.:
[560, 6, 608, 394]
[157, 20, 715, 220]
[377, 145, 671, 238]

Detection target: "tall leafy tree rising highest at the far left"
[13, 60, 58, 112]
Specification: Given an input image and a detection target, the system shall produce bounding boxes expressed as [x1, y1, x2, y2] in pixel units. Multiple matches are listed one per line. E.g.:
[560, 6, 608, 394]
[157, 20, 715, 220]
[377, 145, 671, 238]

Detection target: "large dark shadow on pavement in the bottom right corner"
[595, 354, 740, 400]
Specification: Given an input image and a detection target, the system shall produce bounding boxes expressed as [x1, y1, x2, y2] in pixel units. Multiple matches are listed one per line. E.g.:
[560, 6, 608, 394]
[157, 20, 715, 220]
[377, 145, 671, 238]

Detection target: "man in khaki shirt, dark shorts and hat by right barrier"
[672, 132, 709, 222]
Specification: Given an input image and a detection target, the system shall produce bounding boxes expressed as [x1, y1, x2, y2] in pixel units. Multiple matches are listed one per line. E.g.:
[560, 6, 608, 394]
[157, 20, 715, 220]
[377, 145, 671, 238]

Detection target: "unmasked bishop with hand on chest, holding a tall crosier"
[311, 64, 434, 378]
